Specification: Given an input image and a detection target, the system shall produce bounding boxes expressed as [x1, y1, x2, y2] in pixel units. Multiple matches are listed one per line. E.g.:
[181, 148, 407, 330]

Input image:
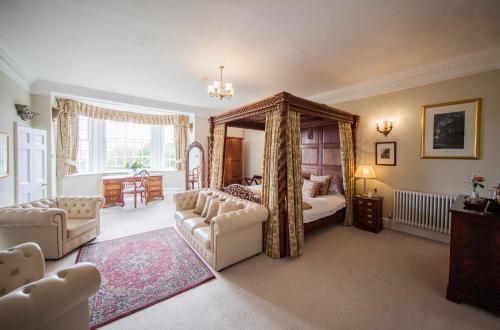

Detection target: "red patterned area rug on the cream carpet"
[76, 227, 215, 329]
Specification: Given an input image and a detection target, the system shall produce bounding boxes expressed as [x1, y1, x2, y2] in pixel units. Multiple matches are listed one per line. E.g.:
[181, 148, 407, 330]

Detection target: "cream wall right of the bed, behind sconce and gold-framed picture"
[334, 70, 500, 216]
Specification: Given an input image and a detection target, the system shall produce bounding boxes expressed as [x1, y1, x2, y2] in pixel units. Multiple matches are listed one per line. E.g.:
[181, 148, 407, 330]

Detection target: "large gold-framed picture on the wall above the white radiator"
[420, 99, 481, 159]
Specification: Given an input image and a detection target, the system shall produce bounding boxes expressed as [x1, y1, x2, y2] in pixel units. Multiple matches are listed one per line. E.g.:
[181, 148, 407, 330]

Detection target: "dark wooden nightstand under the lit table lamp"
[354, 195, 384, 233]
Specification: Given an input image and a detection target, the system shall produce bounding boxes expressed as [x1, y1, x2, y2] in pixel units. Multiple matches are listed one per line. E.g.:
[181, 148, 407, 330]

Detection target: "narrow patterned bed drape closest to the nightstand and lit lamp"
[339, 121, 354, 226]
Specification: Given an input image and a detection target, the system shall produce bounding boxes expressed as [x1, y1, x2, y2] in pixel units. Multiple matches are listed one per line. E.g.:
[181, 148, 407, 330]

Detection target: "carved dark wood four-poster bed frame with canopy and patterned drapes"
[208, 92, 359, 258]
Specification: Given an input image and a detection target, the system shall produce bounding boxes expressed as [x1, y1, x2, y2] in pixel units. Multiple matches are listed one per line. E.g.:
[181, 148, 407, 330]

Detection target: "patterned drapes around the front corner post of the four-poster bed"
[262, 110, 304, 258]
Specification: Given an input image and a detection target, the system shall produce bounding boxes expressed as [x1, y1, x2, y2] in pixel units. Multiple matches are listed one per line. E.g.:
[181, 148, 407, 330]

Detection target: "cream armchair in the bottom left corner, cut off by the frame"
[0, 243, 101, 330]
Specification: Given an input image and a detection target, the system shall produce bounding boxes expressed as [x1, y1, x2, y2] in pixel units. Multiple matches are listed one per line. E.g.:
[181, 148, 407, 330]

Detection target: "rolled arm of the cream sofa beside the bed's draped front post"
[210, 204, 268, 235]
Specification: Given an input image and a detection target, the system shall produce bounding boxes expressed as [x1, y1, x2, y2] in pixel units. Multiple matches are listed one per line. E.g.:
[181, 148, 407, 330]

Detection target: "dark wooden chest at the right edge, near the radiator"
[446, 195, 500, 315]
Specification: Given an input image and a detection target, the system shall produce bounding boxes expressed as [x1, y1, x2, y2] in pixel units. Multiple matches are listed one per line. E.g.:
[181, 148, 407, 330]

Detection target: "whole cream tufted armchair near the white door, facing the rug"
[0, 196, 104, 259]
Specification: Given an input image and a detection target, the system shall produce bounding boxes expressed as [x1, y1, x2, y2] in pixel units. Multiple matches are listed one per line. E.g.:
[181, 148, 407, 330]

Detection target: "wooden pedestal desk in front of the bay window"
[102, 173, 165, 207]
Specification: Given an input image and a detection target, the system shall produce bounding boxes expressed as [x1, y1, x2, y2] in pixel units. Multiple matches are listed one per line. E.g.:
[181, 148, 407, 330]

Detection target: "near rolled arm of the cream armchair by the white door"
[0, 207, 66, 227]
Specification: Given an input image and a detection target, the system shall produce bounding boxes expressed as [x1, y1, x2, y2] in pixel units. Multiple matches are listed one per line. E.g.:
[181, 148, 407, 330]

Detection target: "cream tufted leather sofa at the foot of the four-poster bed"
[174, 189, 268, 271]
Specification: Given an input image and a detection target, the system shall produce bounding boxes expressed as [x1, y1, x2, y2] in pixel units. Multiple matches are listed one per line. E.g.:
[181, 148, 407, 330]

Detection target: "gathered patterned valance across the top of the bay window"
[56, 99, 189, 126]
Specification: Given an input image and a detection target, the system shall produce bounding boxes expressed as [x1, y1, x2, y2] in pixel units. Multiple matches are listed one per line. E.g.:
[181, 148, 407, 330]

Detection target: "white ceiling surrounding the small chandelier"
[0, 0, 500, 113]
